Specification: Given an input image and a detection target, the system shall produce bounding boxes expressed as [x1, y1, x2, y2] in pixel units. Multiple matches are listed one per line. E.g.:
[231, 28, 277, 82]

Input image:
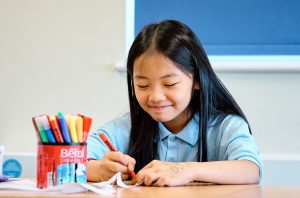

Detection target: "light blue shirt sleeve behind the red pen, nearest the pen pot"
[87, 114, 130, 160]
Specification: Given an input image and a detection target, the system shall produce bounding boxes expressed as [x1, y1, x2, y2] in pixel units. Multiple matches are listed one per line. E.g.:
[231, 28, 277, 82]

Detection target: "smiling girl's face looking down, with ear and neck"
[133, 52, 199, 133]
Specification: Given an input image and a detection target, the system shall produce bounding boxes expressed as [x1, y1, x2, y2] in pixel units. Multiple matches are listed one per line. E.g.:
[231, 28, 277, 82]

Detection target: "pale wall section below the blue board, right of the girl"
[218, 72, 300, 155]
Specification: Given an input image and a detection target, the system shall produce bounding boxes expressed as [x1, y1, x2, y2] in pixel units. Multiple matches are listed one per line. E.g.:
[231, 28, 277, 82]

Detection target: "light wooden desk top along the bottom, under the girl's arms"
[0, 185, 300, 198]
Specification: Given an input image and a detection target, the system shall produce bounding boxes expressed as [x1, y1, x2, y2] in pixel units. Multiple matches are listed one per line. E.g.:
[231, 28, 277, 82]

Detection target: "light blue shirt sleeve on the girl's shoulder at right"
[219, 115, 263, 178]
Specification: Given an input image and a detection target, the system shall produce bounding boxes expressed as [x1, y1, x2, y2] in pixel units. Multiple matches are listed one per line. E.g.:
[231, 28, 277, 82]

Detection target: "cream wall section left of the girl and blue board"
[0, 0, 128, 152]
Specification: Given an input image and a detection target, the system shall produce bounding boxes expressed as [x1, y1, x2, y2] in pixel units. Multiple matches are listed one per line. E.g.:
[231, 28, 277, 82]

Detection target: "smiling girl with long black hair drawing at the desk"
[87, 20, 262, 186]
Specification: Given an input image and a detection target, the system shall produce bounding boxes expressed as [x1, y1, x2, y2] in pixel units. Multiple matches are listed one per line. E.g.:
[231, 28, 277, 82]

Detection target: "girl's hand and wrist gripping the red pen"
[87, 152, 135, 182]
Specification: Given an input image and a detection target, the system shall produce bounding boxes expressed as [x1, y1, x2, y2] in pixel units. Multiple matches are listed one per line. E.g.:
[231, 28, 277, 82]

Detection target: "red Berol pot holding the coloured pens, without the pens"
[37, 143, 87, 188]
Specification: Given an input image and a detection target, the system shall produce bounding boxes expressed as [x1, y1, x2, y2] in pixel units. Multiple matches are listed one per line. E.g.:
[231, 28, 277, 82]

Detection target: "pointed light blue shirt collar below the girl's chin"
[158, 113, 199, 146]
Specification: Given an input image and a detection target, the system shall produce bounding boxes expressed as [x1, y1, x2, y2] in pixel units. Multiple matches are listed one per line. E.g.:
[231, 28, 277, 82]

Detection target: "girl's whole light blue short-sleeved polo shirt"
[87, 113, 262, 179]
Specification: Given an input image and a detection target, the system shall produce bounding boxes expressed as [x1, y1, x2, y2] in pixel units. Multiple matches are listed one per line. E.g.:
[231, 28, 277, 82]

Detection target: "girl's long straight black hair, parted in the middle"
[127, 20, 251, 171]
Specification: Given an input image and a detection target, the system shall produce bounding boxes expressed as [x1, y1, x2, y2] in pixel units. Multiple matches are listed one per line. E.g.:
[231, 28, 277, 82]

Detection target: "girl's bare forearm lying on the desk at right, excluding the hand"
[184, 160, 259, 184]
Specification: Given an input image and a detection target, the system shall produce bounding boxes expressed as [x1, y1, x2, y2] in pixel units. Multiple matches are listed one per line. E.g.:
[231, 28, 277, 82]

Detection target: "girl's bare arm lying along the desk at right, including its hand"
[136, 160, 259, 186]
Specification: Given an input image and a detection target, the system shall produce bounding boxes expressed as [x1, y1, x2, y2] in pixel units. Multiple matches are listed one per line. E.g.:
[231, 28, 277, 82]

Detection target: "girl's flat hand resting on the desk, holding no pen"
[135, 160, 193, 186]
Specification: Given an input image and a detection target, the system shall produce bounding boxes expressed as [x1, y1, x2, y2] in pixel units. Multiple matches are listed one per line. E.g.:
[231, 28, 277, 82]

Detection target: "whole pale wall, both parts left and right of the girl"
[0, 0, 300, 185]
